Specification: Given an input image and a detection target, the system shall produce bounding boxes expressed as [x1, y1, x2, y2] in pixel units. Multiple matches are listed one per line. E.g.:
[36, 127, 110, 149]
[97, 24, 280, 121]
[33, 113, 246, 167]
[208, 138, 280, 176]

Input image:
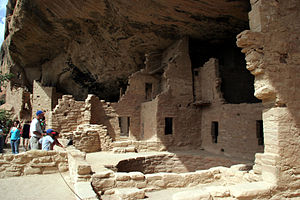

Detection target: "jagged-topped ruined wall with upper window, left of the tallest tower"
[114, 71, 159, 140]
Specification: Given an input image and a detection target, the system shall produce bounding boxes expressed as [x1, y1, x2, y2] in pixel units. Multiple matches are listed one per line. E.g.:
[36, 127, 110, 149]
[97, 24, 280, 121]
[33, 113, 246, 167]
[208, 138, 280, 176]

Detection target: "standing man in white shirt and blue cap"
[29, 110, 44, 149]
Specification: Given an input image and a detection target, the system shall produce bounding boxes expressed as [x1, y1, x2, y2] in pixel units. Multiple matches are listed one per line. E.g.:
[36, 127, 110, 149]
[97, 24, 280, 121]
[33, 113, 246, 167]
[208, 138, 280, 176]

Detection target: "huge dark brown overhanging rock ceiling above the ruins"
[1, 0, 250, 101]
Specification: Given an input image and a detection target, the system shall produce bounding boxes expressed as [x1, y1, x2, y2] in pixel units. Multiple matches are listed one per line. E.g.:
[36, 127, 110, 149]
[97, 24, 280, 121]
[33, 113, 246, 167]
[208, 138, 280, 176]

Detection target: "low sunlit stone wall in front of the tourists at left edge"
[0, 150, 68, 178]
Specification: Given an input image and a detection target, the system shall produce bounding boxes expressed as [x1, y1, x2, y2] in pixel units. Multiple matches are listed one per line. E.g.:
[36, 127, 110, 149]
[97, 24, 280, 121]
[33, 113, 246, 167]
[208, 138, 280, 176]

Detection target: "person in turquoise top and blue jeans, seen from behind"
[5, 121, 21, 154]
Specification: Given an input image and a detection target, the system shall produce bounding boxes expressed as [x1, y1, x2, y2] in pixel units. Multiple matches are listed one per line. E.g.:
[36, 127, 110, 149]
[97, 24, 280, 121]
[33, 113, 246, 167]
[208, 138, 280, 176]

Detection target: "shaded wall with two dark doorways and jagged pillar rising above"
[196, 59, 264, 160]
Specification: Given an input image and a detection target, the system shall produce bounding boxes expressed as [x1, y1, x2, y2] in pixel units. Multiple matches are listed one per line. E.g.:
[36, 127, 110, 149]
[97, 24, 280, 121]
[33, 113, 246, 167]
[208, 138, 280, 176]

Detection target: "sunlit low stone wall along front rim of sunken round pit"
[92, 165, 254, 195]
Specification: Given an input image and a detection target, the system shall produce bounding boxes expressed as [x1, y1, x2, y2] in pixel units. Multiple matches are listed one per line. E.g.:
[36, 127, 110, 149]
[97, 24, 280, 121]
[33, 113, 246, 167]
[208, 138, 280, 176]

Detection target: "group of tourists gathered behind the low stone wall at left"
[0, 110, 64, 154]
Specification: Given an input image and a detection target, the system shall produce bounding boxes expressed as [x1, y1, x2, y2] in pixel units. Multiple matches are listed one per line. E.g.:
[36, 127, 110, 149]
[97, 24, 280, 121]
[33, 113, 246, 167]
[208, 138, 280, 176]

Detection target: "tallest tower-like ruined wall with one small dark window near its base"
[156, 38, 201, 148]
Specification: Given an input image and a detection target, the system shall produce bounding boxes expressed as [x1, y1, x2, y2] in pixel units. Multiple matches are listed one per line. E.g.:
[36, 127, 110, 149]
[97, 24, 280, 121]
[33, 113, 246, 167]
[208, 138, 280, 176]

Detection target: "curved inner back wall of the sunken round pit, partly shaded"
[116, 154, 246, 174]
